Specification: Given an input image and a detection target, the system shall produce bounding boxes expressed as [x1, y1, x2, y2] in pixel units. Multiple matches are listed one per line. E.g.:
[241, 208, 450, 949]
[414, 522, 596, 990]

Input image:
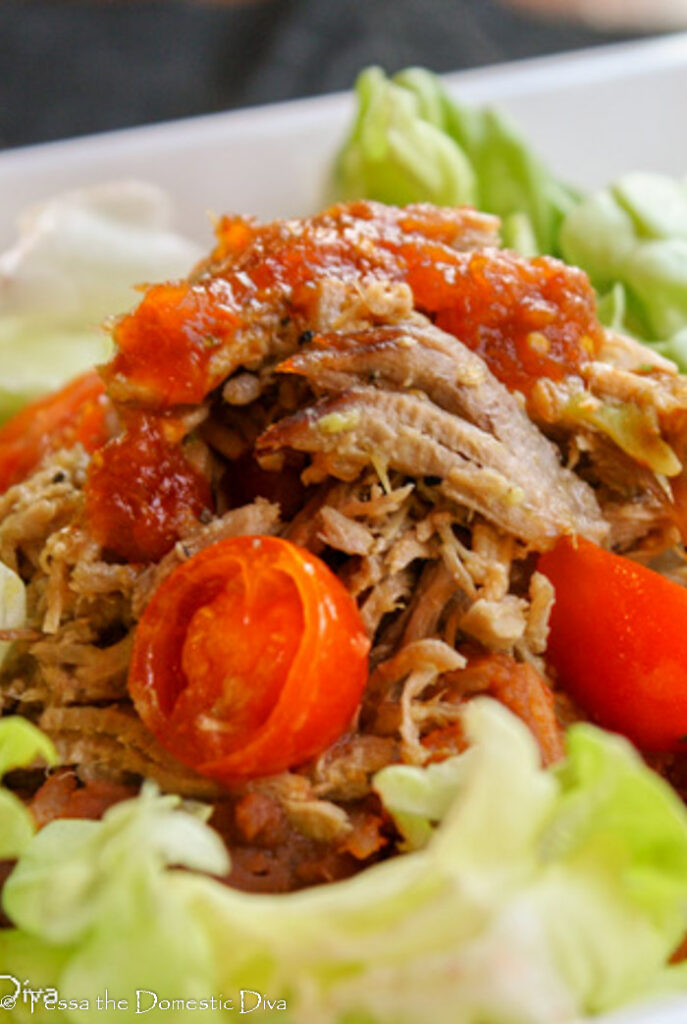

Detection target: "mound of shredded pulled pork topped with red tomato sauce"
[0, 203, 687, 891]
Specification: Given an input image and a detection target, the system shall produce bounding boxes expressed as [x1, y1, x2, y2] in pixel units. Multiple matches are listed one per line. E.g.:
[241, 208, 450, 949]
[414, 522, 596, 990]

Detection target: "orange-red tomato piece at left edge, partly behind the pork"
[0, 370, 110, 493]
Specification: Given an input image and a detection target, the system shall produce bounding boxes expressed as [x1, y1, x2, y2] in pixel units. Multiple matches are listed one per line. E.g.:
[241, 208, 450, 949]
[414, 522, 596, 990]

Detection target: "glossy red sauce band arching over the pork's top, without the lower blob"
[105, 202, 600, 409]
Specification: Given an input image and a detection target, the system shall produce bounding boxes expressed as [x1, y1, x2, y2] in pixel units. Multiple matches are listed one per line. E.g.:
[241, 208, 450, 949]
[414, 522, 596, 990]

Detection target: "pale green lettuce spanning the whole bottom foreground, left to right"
[0, 698, 687, 1024]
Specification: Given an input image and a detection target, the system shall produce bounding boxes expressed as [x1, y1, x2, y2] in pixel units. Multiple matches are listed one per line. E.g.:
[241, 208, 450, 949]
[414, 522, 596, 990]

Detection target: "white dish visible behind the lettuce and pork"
[0, 34, 687, 1024]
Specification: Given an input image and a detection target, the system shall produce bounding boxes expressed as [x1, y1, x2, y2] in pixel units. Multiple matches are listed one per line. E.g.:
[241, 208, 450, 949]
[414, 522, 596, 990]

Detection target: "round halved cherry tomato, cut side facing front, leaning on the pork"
[129, 537, 370, 781]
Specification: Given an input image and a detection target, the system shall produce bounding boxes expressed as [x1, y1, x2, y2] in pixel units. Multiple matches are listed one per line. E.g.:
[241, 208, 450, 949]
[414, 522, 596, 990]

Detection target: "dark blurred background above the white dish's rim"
[0, 0, 659, 147]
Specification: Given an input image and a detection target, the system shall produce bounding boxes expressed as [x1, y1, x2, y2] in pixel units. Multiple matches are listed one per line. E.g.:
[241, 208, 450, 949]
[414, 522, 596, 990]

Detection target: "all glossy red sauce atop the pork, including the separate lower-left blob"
[95, 202, 601, 559]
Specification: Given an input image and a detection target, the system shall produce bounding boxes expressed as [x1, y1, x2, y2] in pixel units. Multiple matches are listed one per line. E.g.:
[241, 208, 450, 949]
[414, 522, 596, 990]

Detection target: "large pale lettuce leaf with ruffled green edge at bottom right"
[190, 700, 687, 1024]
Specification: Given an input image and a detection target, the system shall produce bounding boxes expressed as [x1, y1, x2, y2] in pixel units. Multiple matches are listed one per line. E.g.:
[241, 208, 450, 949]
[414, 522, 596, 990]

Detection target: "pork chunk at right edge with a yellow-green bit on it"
[529, 332, 687, 551]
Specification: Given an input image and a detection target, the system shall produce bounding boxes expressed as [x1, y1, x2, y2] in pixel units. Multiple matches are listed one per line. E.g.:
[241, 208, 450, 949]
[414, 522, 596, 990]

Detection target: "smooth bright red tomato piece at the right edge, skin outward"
[539, 538, 687, 751]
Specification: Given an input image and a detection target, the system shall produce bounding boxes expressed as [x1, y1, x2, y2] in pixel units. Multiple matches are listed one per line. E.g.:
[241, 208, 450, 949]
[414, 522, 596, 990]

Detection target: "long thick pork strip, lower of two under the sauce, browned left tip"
[257, 387, 606, 548]
